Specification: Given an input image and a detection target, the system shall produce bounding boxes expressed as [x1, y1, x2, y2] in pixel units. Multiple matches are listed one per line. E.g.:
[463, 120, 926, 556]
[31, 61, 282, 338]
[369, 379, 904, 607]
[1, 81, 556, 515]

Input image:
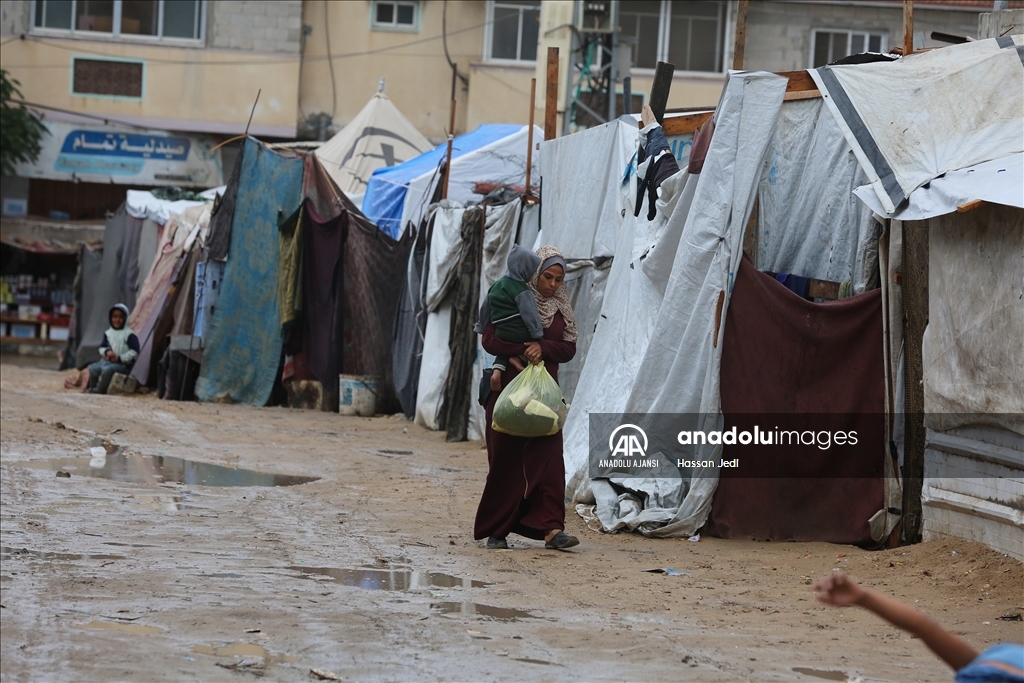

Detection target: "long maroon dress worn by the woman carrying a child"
[473, 312, 575, 541]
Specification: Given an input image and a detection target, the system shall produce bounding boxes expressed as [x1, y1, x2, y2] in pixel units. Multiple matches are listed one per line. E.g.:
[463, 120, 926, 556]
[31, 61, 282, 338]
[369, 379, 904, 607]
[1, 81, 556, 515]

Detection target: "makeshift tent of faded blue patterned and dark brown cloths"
[189, 138, 412, 412]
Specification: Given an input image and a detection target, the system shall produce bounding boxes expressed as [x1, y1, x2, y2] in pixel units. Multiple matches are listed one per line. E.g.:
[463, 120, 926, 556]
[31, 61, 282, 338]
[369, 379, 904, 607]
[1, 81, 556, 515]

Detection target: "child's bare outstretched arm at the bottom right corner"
[814, 571, 978, 671]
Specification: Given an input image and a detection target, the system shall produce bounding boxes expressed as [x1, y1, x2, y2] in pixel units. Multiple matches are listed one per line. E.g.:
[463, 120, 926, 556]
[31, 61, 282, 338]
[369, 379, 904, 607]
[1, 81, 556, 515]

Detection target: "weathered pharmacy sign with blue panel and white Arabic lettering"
[17, 121, 223, 187]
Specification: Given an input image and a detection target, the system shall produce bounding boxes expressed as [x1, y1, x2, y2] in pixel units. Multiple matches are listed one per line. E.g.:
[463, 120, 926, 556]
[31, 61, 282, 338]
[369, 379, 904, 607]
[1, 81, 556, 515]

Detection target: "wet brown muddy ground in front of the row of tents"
[0, 357, 1024, 681]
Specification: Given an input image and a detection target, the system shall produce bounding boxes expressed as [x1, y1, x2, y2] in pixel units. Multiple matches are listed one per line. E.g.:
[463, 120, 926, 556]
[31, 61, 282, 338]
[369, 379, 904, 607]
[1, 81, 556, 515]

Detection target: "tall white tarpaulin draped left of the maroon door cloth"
[561, 73, 786, 537]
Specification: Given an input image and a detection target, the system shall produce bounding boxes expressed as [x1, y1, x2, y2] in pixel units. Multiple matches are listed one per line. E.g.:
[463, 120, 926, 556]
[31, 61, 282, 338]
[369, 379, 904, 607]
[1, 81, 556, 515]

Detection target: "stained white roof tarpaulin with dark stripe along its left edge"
[810, 36, 1024, 214]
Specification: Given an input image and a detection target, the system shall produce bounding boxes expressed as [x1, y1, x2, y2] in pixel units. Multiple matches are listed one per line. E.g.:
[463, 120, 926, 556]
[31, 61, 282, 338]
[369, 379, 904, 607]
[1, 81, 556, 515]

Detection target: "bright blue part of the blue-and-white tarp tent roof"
[362, 124, 522, 239]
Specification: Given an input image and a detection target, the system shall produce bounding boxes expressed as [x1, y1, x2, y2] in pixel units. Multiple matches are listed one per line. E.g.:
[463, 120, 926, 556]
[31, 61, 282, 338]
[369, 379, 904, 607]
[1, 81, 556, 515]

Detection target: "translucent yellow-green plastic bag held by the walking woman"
[490, 360, 569, 436]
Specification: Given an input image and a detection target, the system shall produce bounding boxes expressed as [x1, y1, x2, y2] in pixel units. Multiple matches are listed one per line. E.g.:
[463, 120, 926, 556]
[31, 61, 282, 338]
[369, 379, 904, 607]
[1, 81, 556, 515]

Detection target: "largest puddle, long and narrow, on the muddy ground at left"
[12, 451, 319, 489]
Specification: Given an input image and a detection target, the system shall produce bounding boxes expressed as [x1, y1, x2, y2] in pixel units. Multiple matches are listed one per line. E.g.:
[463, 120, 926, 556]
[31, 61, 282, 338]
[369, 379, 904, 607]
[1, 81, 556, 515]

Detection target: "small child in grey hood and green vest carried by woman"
[474, 245, 544, 391]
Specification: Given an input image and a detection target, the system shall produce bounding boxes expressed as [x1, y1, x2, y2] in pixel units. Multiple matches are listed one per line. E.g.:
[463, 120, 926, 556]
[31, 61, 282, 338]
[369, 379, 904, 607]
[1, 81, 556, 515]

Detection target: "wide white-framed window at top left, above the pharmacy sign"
[33, 0, 205, 40]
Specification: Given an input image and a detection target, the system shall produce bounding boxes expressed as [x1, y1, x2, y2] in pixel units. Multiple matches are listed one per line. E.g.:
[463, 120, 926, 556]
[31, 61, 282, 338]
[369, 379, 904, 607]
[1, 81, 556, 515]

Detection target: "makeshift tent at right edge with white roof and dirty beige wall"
[811, 34, 1024, 559]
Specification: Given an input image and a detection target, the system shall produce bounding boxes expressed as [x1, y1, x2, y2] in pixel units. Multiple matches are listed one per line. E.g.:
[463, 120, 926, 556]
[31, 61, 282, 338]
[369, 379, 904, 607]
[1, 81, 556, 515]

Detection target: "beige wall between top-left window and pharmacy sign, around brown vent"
[0, 38, 299, 137]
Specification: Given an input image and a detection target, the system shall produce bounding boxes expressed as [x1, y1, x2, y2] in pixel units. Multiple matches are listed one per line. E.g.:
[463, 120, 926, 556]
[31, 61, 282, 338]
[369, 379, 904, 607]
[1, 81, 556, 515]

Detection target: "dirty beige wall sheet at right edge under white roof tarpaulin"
[922, 205, 1024, 435]
